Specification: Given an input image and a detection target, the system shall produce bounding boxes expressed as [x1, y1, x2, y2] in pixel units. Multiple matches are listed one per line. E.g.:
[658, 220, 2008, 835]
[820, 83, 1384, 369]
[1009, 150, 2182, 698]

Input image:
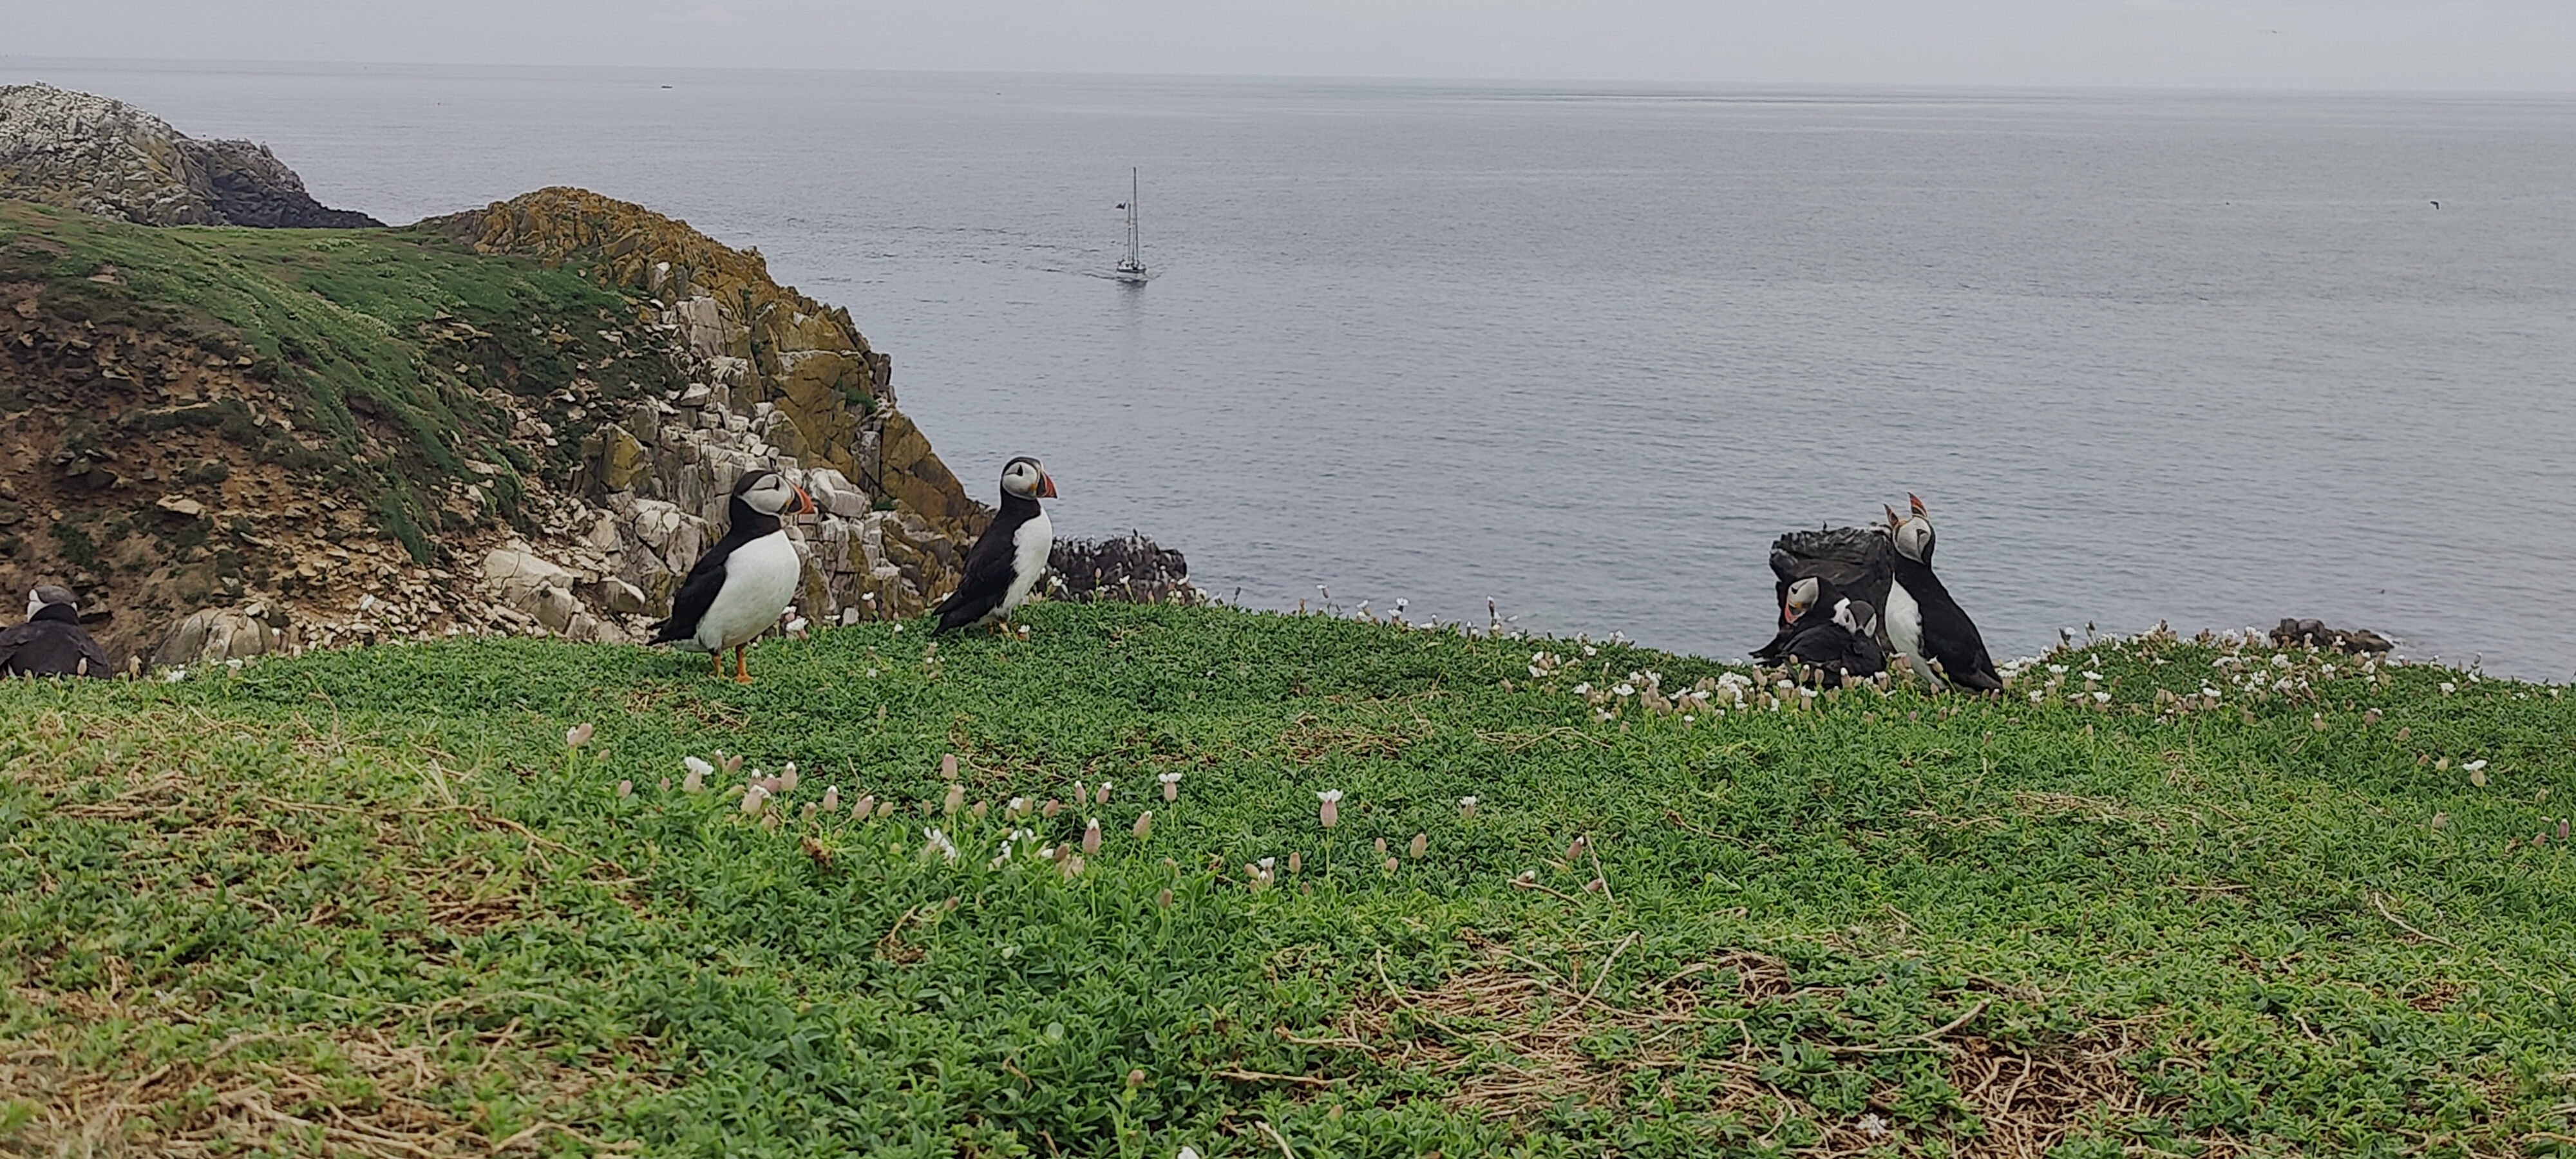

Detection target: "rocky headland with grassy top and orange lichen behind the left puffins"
[0, 191, 1036, 662]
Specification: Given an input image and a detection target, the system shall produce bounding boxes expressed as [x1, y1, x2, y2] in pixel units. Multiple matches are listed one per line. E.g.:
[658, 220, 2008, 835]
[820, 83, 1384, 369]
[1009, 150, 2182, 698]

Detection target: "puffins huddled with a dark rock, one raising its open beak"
[1754, 495, 2004, 693]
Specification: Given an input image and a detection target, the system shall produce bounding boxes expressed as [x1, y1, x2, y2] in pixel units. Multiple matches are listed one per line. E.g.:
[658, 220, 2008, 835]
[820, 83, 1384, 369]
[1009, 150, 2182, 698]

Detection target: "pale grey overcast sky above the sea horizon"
[0, 0, 2576, 93]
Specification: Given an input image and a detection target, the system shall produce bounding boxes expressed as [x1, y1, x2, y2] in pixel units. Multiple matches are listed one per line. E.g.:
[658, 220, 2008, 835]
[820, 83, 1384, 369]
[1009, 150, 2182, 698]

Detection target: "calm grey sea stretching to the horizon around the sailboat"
[20, 57, 2576, 680]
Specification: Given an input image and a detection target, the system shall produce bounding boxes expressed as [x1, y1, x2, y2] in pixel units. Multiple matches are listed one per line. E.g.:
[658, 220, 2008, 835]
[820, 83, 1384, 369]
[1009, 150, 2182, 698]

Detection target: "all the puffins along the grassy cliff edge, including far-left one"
[0, 456, 2004, 693]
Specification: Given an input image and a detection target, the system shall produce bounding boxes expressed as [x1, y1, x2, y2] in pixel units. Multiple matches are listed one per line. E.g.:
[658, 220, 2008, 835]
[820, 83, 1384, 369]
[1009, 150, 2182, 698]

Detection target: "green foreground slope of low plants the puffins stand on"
[0, 605, 2576, 1156]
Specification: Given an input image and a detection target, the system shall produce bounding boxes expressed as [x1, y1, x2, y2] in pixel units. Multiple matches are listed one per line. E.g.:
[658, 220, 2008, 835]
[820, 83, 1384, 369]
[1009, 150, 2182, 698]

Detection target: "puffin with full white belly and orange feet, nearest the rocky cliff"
[652, 471, 814, 685]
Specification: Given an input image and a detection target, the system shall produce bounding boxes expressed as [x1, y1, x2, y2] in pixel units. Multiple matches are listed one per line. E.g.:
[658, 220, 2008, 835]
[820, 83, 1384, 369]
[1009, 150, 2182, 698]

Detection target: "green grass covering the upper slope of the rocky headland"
[0, 201, 672, 561]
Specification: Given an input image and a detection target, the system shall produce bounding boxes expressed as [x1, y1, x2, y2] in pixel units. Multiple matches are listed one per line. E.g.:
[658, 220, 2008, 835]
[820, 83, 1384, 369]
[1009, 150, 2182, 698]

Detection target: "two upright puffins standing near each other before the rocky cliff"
[652, 456, 1056, 685]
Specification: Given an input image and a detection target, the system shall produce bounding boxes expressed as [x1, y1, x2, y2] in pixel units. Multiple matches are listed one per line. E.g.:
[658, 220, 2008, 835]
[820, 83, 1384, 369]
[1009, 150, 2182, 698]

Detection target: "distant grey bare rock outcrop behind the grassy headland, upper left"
[0, 85, 384, 227]
